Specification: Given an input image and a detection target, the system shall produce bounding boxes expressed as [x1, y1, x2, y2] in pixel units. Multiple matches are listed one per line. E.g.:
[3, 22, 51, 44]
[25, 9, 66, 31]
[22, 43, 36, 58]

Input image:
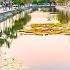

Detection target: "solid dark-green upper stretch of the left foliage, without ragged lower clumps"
[12, 14, 31, 32]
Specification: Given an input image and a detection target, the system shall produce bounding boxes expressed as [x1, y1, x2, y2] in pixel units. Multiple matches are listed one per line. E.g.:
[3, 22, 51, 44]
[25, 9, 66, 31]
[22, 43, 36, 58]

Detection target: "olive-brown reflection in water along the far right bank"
[42, 7, 70, 24]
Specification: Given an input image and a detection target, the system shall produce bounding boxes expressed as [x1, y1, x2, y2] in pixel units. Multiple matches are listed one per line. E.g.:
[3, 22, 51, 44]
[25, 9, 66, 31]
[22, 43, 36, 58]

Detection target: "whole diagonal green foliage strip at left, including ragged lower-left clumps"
[0, 13, 31, 48]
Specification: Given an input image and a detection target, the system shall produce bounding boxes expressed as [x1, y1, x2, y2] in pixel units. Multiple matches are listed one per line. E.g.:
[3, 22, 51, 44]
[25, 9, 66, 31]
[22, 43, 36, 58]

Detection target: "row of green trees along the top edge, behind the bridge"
[12, 0, 70, 5]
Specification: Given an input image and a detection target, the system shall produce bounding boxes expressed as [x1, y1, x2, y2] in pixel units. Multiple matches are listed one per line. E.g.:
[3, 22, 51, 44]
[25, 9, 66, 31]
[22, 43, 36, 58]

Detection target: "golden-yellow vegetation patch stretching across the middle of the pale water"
[24, 23, 70, 35]
